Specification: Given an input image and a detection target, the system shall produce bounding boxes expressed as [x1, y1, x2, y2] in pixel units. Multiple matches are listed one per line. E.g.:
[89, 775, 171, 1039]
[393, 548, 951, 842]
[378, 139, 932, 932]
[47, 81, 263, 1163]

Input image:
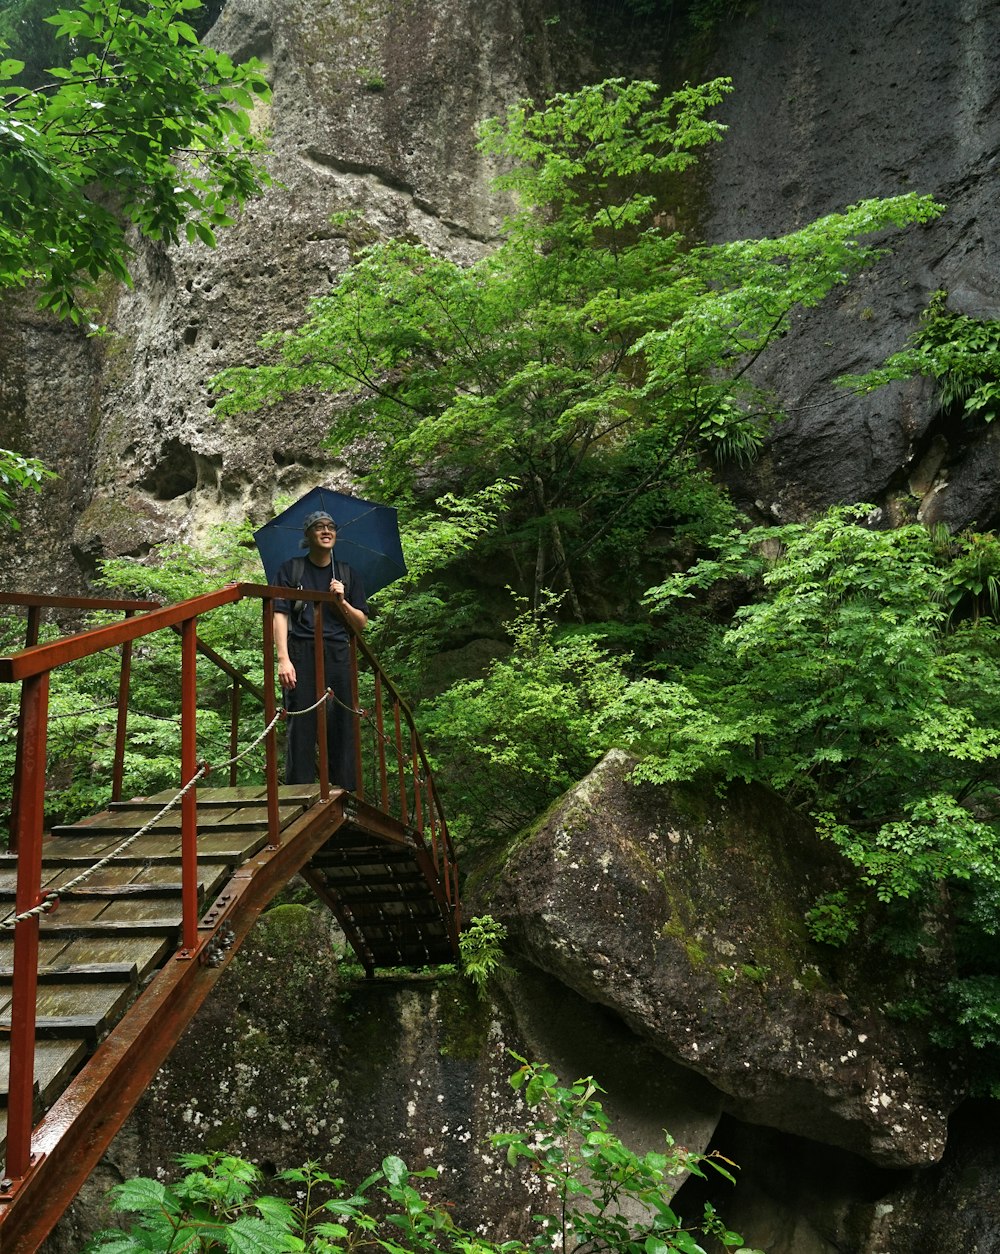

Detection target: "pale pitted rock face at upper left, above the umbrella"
[0, 0, 529, 592]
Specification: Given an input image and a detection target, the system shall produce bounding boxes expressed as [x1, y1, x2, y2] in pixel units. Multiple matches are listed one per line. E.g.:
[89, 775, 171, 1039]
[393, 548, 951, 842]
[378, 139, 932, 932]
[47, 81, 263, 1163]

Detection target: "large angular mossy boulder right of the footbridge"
[491, 752, 957, 1166]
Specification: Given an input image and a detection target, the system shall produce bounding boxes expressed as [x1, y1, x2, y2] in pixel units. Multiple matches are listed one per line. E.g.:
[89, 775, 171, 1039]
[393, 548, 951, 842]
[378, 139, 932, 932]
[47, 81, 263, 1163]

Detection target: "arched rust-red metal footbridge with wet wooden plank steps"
[0, 584, 459, 1254]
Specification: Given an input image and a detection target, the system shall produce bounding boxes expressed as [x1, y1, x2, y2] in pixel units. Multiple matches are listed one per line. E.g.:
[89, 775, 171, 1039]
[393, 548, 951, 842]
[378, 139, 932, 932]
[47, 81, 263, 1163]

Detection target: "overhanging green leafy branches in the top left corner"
[0, 0, 269, 321]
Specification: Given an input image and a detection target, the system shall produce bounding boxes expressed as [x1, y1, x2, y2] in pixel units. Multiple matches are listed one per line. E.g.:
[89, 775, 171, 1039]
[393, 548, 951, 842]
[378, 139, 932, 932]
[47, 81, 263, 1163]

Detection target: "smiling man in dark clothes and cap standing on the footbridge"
[275, 510, 368, 791]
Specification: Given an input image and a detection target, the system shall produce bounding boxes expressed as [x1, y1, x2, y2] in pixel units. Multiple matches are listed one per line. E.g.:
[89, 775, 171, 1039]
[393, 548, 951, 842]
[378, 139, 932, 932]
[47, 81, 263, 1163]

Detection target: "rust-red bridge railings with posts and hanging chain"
[0, 583, 458, 1179]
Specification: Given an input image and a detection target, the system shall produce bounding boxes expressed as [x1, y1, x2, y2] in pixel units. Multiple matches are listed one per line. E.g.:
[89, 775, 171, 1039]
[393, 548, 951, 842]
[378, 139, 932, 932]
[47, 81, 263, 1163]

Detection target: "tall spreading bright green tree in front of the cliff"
[217, 79, 941, 616]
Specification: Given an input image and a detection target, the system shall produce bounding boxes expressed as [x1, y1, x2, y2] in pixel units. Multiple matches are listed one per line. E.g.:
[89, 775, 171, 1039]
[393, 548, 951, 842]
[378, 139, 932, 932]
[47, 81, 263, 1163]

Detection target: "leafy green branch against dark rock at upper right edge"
[838, 291, 1000, 423]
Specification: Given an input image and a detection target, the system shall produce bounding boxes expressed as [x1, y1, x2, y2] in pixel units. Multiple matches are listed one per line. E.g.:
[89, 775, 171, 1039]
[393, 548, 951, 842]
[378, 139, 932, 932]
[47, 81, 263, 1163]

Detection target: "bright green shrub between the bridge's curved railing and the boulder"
[419, 603, 624, 841]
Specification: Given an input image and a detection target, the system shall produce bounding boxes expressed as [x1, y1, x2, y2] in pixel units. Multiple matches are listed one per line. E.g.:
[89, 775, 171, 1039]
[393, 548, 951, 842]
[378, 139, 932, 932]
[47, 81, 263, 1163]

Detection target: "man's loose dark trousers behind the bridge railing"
[285, 638, 358, 793]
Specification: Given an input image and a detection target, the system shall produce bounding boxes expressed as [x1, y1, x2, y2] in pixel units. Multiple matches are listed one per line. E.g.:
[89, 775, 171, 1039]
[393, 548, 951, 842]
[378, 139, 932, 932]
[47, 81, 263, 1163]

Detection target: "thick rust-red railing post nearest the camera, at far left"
[6, 671, 49, 1180]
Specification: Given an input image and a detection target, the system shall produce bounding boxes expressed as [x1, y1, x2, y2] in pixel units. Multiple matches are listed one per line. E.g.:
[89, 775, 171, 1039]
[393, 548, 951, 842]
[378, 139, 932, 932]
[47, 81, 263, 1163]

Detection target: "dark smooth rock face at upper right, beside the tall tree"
[706, 0, 1000, 528]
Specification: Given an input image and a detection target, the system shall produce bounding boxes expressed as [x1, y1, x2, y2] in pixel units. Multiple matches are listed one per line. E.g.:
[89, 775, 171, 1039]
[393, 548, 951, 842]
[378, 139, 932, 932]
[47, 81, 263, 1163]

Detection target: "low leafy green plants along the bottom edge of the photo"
[85, 1060, 759, 1254]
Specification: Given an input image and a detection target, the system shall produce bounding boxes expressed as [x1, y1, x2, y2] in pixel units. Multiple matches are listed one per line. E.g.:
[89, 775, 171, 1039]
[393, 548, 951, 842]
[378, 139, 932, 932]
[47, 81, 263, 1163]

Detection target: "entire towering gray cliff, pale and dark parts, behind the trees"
[0, 0, 1000, 591]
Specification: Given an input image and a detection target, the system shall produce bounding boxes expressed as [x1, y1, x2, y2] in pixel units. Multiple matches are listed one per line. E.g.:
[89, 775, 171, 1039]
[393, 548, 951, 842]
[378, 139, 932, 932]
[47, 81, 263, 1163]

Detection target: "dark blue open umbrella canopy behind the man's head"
[253, 488, 407, 597]
